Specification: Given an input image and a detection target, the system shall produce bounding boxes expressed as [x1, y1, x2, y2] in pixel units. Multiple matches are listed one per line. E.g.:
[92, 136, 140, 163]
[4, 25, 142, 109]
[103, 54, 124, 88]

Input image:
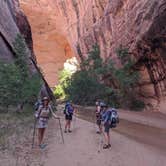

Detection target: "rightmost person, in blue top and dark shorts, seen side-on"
[102, 105, 112, 149]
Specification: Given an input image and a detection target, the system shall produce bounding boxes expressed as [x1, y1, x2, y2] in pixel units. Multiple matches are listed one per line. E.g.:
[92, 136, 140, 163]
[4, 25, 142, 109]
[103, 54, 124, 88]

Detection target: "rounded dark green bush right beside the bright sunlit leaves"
[64, 71, 109, 105]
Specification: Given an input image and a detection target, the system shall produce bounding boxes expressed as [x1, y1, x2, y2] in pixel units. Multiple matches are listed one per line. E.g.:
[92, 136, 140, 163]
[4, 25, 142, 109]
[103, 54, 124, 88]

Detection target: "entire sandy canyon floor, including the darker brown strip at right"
[0, 106, 166, 166]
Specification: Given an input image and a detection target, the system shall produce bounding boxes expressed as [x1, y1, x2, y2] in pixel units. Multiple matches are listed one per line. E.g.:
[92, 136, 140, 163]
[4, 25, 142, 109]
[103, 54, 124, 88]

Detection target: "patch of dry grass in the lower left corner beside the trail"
[0, 106, 38, 166]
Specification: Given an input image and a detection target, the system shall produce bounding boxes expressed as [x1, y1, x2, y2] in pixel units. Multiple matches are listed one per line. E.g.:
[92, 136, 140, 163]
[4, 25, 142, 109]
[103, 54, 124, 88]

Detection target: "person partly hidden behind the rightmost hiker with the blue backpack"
[96, 100, 103, 134]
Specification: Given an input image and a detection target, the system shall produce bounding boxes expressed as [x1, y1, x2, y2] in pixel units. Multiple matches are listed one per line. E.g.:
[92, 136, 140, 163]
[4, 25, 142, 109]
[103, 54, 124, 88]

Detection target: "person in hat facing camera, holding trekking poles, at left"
[35, 97, 59, 149]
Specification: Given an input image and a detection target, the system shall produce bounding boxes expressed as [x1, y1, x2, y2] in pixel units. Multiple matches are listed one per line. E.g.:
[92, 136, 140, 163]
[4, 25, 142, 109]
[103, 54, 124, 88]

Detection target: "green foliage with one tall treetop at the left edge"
[0, 35, 42, 107]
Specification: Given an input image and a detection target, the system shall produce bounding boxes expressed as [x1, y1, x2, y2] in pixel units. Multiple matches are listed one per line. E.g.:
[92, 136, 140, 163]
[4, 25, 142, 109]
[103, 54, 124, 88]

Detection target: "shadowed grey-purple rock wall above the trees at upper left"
[0, 0, 35, 71]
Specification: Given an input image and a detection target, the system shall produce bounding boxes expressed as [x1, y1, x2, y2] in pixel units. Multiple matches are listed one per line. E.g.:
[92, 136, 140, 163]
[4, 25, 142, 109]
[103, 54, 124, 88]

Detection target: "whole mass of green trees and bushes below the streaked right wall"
[57, 45, 143, 108]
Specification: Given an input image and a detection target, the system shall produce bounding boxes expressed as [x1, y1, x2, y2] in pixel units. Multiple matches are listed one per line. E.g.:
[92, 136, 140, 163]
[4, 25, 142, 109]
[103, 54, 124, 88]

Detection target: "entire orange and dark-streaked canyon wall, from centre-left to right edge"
[20, 0, 166, 111]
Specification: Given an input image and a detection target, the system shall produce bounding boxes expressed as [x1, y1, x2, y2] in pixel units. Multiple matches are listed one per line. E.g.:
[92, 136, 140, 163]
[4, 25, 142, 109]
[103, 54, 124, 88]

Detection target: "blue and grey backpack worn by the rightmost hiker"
[109, 108, 119, 128]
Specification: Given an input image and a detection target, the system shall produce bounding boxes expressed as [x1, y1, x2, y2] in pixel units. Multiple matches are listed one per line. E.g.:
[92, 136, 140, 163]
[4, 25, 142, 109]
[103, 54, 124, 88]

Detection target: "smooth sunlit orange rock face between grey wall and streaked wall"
[20, 0, 75, 87]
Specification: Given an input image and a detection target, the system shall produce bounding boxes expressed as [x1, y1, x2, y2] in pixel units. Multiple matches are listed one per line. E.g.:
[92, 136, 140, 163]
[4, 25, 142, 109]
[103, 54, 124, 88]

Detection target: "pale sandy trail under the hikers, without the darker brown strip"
[43, 118, 166, 166]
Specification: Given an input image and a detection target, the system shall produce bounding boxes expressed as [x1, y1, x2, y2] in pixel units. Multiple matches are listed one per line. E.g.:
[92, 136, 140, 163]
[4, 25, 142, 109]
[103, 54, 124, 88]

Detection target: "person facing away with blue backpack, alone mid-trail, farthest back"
[64, 102, 74, 133]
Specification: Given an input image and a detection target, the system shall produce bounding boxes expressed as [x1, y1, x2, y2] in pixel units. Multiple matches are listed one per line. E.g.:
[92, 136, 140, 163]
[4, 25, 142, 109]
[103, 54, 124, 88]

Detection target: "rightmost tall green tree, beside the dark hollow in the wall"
[114, 46, 144, 109]
